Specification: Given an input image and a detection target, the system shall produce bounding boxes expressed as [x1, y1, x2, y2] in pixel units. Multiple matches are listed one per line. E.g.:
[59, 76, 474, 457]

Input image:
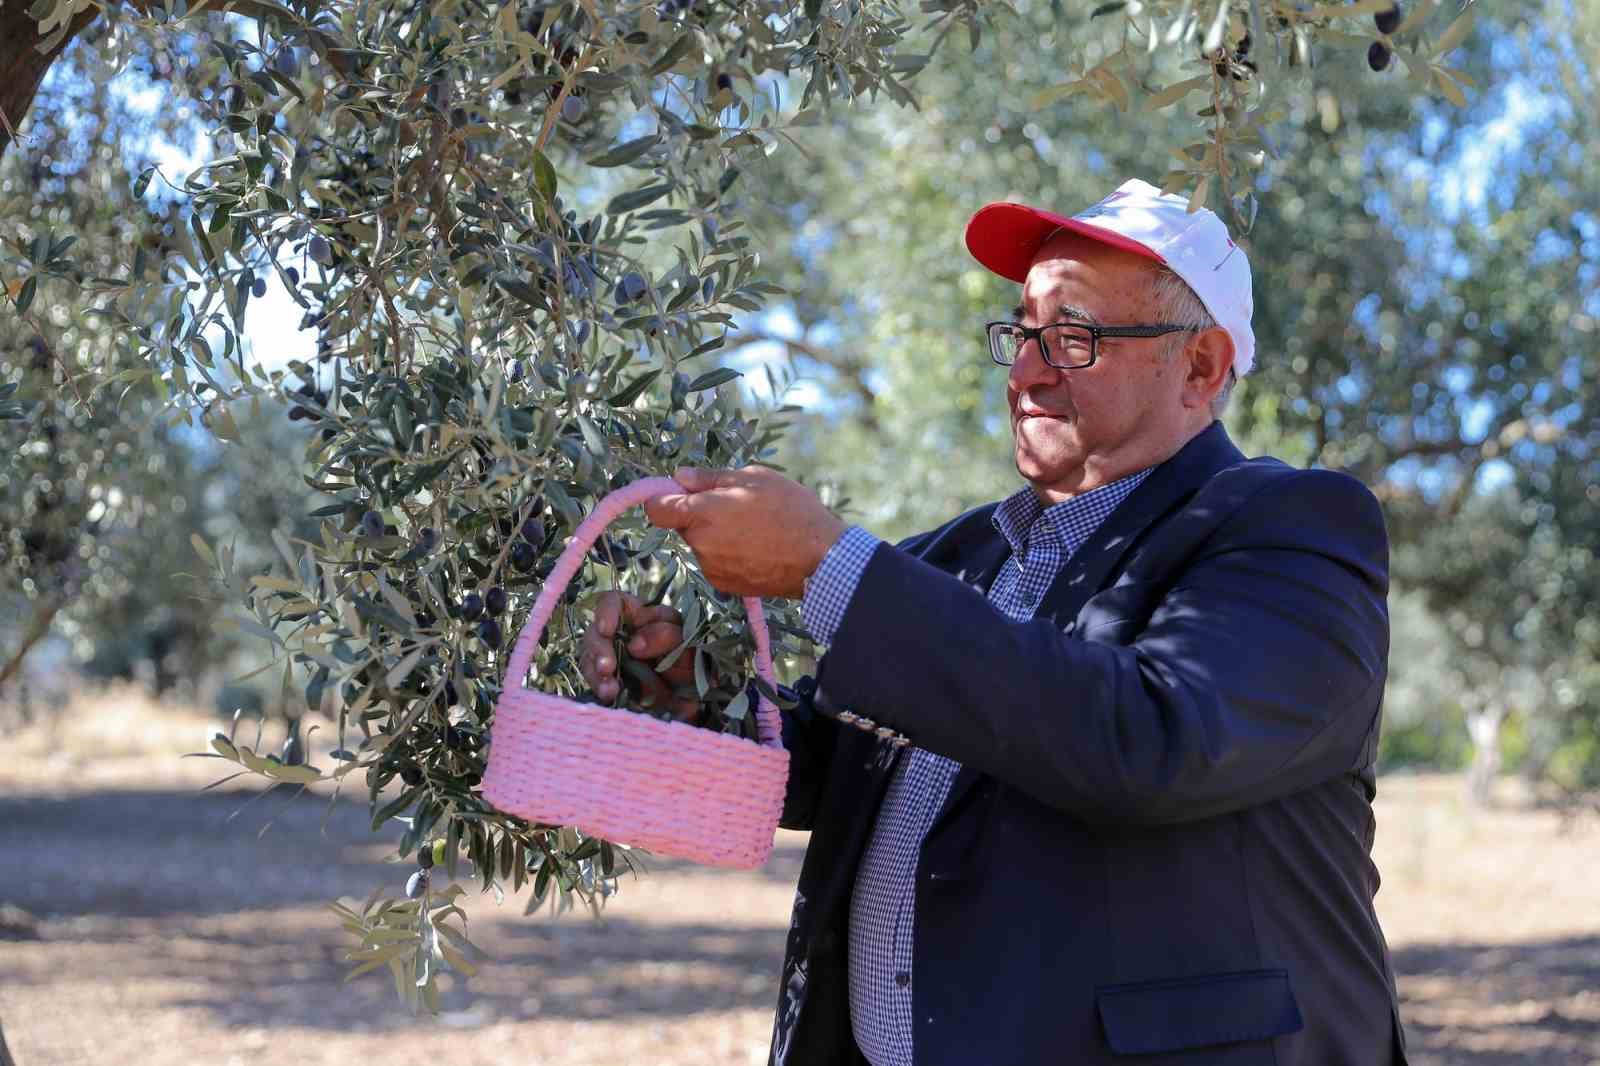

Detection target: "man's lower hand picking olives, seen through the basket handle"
[578, 591, 701, 722]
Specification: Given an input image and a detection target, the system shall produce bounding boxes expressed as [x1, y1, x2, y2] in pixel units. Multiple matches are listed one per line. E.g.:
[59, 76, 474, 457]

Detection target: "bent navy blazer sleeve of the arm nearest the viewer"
[821, 471, 1389, 824]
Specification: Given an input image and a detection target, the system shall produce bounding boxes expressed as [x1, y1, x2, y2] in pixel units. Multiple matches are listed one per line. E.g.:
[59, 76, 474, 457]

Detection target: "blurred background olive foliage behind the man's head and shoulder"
[746, 3, 1600, 784]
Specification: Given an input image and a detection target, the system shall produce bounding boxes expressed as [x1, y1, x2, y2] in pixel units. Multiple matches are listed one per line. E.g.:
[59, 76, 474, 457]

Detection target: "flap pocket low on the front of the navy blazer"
[1094, 970, 1306, 1055]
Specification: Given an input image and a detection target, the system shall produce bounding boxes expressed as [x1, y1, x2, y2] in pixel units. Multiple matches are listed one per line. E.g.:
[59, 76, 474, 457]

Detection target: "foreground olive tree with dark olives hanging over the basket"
[0, 0, 1467, 1007]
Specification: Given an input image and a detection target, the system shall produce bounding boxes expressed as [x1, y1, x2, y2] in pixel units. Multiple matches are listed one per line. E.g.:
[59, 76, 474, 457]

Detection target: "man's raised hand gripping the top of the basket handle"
[645, 466, 846, 597]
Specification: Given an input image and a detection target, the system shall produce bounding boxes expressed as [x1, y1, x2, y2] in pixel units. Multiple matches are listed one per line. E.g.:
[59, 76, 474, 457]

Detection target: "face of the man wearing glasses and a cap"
[1006, 232, 1190, 503]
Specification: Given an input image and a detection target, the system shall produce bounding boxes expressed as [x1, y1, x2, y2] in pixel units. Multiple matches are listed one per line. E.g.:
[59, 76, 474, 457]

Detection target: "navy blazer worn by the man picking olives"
[771, 423, 1405, 1066]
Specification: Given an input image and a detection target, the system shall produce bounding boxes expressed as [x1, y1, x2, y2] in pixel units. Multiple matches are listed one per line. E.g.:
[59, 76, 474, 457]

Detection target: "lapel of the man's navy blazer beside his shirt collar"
[930, 421, 1245, 832]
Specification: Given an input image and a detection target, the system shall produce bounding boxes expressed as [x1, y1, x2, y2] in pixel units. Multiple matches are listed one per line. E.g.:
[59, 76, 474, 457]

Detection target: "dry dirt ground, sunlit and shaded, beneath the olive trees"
[0, 681, 1600, 1066]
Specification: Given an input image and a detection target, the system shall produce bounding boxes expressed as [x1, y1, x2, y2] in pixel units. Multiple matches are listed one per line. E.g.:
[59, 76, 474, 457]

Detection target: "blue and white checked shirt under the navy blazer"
[802, 469, 1150, 1066]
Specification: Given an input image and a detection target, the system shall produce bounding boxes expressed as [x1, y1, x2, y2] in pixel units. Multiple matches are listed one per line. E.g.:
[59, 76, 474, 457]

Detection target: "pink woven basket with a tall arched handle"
[483, 477, 789, 869]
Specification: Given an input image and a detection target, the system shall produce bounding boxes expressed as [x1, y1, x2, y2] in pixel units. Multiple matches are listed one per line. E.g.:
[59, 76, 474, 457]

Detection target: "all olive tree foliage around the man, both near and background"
[0, 0, 1600, 1002]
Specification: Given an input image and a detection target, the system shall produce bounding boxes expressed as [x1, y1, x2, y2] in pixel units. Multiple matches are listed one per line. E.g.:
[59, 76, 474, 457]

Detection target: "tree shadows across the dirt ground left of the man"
[0, 789, 803, 1031]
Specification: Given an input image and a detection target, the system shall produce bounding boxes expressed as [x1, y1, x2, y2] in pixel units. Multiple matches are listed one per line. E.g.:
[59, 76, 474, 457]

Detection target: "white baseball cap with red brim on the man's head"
[966, 179, 1256, 378]
